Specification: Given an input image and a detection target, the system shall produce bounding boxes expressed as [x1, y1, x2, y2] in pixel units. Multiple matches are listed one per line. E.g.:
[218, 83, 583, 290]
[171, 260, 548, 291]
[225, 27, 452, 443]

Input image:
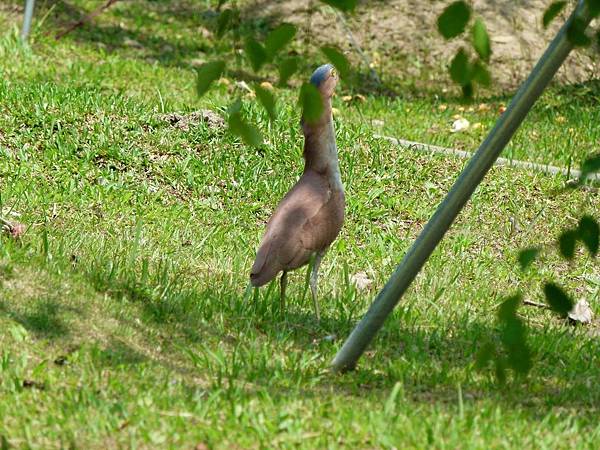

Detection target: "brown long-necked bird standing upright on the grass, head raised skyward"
[250, 64, 345, 320]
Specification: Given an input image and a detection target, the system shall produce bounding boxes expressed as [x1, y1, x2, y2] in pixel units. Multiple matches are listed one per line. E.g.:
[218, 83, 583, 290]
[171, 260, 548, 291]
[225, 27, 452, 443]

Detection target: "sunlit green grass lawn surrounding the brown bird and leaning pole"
[0, 2, 600, 449]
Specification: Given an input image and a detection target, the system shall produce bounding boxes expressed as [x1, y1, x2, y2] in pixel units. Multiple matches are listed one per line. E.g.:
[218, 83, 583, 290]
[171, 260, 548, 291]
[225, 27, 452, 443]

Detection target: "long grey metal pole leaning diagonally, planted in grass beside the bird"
[331, 0, 591, 372]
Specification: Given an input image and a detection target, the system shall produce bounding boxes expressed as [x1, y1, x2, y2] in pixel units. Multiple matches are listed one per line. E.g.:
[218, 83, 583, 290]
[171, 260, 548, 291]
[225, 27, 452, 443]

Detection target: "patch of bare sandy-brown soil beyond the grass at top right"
[248, 0, 600, 89]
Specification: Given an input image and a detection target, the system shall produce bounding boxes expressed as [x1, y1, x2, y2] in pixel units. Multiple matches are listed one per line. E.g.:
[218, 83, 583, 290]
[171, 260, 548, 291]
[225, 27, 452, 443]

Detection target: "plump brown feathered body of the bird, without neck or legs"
[250, 170, 344, 286]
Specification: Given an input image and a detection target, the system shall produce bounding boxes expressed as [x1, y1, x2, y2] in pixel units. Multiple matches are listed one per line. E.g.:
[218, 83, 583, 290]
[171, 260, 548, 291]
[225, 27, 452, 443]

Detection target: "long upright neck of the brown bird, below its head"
[302, 101, 343, 190]
